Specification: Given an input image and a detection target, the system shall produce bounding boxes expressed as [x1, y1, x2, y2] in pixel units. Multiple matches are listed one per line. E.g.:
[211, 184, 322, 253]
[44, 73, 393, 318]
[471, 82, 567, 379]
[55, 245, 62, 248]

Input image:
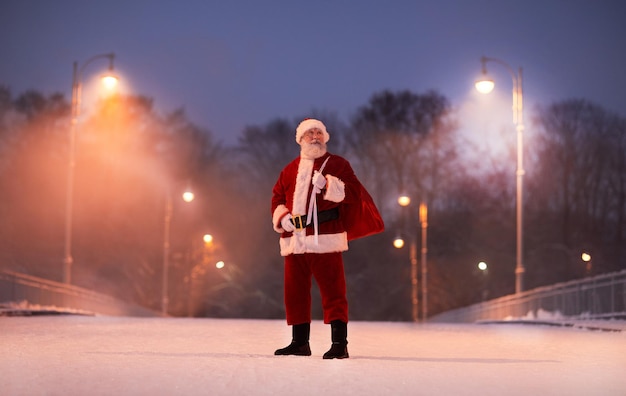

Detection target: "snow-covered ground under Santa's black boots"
[0, 315, 626, 396]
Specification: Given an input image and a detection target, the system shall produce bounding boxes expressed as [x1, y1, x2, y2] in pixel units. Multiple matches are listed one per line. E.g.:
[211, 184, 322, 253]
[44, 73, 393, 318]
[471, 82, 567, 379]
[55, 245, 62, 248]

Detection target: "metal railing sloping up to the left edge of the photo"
[0, 270, 159, 316]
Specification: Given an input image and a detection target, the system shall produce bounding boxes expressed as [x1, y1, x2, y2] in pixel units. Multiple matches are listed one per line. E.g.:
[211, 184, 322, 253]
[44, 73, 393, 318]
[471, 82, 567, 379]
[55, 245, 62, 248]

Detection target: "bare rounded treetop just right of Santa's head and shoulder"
[346, 91, 456, 215]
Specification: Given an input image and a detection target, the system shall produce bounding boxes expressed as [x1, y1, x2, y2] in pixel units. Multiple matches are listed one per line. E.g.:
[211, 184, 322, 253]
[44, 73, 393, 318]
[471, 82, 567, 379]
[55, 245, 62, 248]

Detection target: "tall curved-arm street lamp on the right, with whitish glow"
[476, 56, 525, 293]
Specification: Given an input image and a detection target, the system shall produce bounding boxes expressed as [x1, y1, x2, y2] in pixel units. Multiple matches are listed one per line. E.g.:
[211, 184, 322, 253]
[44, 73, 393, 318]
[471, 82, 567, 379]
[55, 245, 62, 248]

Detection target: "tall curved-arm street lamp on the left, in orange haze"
[63, 53, 117, 284]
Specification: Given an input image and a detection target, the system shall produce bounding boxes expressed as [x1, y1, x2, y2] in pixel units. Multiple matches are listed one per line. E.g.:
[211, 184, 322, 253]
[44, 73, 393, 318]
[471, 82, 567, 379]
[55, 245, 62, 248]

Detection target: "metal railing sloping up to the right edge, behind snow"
[429, 270, 626, 323]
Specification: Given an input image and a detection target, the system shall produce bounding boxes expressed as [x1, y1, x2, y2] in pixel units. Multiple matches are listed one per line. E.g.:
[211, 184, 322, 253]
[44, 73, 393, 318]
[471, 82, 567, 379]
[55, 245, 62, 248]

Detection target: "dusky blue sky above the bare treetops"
[0, 0, 626, 143]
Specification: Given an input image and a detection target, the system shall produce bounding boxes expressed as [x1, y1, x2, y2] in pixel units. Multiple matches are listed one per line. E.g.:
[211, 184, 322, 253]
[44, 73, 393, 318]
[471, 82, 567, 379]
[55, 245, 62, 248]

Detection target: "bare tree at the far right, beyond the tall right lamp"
[529, 100, 626, 284]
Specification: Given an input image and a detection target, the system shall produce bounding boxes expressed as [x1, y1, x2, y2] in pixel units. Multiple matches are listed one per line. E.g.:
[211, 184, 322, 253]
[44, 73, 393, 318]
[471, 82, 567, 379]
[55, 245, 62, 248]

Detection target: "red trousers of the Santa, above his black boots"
[285, 252, 348, 325]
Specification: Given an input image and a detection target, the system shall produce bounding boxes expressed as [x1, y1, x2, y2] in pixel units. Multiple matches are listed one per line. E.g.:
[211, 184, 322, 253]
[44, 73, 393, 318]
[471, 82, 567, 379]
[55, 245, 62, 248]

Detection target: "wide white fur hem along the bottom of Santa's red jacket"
[279, 230, 348, 256]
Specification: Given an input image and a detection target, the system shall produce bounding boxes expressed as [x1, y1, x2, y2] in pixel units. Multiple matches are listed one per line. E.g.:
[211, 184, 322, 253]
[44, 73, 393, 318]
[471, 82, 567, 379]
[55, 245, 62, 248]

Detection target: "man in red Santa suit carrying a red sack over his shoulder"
[272, 118, 383, 359]
